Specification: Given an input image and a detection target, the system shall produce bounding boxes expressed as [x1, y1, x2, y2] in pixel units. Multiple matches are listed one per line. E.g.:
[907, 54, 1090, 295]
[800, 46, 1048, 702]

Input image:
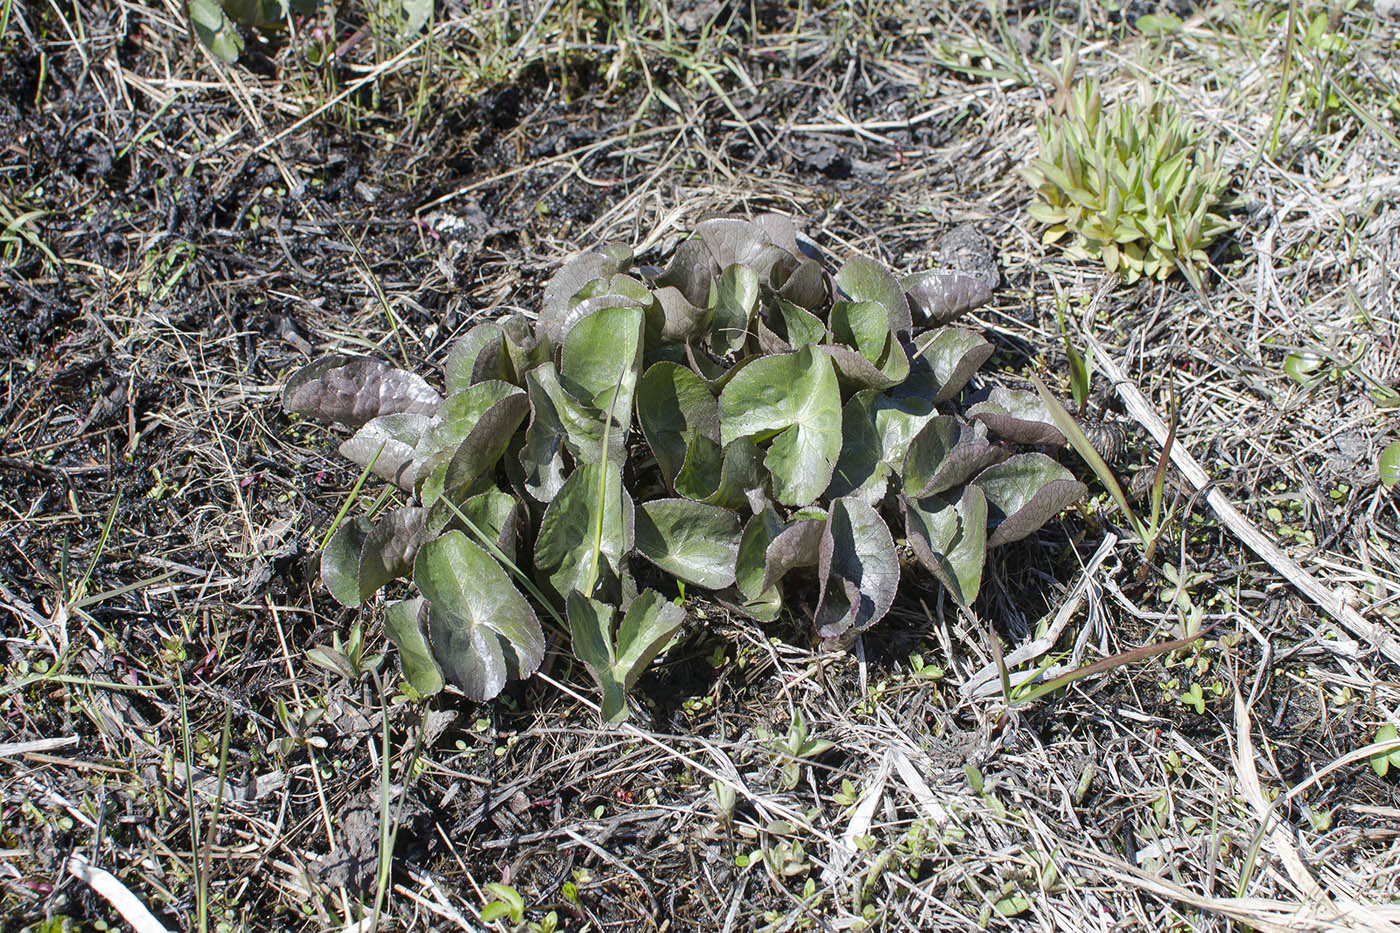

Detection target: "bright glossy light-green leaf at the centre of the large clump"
[720, 347, 841, 506]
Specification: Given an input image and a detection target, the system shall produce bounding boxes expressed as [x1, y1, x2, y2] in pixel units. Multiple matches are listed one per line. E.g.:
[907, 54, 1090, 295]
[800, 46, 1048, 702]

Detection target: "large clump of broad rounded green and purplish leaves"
[283, 214, 1084, 720]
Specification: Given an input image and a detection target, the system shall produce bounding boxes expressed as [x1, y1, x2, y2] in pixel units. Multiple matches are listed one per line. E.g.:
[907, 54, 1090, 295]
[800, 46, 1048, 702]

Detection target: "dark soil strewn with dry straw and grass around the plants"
[0, 0, 1400, 930]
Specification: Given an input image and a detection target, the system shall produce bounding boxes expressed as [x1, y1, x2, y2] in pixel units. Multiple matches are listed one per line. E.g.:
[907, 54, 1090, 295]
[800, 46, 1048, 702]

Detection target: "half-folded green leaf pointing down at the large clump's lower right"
[904, 485, 987, 608]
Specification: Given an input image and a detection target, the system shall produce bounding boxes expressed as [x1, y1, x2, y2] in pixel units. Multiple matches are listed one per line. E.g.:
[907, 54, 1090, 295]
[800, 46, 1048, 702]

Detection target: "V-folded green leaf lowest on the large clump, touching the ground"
[567, 590, 686, 723]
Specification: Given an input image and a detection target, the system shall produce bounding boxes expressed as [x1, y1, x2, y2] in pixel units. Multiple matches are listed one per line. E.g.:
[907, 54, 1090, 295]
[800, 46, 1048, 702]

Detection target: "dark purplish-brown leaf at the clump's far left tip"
[281, 353, 442, 429]
